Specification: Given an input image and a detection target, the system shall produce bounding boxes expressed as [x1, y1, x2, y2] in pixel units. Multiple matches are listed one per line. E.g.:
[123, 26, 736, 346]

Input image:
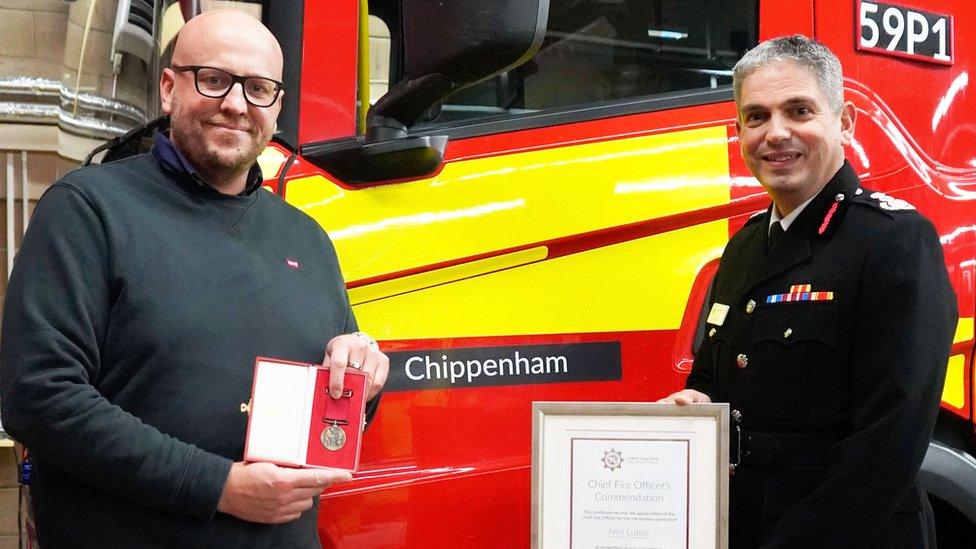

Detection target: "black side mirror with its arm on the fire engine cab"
[302, 0, 549, 183]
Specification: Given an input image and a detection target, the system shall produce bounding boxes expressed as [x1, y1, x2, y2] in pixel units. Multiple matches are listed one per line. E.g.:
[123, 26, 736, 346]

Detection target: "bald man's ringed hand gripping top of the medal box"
[322, 332, 390, 400]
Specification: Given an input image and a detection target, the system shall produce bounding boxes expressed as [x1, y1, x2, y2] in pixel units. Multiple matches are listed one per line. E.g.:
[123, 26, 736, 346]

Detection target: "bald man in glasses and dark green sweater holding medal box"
[0, 11, 389, 548]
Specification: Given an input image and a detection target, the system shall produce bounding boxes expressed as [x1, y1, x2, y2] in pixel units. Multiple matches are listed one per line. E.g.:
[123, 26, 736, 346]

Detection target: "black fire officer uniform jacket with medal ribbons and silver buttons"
[687, 163, 957, 549]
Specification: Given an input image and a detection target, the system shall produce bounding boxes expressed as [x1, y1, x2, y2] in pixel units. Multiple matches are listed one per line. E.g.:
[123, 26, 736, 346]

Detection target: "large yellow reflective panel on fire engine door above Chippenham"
[285, 126, 729, 338]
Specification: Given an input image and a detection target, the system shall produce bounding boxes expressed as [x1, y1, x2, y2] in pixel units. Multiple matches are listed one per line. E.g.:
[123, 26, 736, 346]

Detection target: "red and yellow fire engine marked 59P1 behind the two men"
[112, 0, 976, 548]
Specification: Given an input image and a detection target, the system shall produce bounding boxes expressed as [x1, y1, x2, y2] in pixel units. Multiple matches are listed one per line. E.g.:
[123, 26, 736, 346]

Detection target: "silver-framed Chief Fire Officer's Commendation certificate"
[532, 402, 729, 549]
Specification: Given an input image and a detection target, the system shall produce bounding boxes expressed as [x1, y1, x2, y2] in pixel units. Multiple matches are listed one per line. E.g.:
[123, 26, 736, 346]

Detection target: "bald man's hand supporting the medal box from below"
[217, 462, 352, 524]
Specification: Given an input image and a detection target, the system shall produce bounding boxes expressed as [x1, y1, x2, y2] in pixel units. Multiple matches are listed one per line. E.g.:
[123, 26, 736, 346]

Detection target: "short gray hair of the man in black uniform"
[732, 34, 844, 114]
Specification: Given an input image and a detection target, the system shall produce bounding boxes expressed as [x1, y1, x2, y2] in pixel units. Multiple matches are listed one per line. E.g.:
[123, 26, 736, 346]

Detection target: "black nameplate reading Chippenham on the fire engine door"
[383, 341, 621, 391]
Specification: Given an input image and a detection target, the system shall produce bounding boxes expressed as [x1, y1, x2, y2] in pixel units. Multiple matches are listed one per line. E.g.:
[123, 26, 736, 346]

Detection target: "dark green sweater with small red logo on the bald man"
[0, 144, 356, 547]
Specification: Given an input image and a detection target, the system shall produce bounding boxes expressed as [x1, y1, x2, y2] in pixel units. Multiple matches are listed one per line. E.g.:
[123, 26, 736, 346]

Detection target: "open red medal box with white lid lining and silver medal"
[244, 357, 369, 471]
